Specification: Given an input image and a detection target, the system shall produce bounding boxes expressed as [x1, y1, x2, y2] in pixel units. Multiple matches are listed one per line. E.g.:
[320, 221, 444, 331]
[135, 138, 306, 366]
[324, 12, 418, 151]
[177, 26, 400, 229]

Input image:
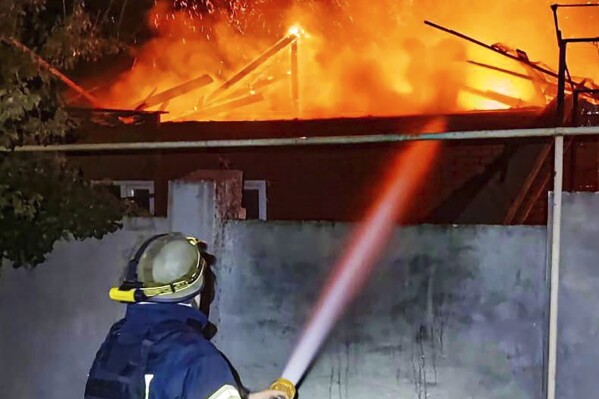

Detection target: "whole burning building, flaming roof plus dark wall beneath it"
[29, 0, 599, 223]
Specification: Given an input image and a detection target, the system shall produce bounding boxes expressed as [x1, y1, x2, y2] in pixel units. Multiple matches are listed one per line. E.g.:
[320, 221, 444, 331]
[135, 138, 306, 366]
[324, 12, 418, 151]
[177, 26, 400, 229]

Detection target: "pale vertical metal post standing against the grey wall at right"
[547, 136, 564, 399]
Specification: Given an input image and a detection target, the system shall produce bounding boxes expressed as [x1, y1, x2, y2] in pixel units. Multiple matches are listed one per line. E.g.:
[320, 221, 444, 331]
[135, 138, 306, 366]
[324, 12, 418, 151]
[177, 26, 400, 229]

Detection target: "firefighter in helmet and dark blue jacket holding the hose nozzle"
[85, 233, 295, 399]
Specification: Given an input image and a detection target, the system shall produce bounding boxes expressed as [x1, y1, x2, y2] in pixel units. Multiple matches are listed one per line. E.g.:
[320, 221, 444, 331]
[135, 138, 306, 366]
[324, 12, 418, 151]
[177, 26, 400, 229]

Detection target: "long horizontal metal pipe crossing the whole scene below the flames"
[0, 126, 599, 152]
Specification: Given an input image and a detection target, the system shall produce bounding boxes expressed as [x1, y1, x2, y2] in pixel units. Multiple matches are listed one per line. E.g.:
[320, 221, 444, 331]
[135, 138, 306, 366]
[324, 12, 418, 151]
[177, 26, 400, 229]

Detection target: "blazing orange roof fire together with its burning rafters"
[61, 0, 599, 121]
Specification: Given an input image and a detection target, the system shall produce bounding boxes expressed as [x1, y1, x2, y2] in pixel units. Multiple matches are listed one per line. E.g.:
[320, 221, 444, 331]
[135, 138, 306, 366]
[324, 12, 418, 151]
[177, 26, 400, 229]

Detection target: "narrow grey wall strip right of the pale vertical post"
[557, 193, 599, 399]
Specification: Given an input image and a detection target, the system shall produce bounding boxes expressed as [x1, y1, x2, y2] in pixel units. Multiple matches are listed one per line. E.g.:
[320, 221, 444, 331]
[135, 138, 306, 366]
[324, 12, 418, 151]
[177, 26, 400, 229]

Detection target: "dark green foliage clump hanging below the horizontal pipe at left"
[0, 154, 133, 267]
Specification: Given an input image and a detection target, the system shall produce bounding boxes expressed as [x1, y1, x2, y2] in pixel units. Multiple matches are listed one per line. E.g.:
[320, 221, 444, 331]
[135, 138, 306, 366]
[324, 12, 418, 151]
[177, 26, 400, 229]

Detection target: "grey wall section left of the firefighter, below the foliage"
[0, 219, 166, 399]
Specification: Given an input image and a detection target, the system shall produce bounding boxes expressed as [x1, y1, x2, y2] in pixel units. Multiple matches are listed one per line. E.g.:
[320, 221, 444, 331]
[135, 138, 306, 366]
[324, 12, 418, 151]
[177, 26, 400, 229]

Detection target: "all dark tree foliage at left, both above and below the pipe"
[0, 0, 142, 267]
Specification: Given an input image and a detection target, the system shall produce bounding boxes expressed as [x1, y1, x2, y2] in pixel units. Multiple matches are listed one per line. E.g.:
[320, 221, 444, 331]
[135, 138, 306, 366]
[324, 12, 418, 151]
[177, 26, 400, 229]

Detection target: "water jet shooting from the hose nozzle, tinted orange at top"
[271, 138, 439, 398]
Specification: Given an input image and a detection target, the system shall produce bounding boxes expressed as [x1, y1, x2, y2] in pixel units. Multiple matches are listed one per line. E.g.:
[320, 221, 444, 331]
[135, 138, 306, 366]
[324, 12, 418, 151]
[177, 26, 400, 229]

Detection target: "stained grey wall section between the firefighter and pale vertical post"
[215, 223, 546, 399]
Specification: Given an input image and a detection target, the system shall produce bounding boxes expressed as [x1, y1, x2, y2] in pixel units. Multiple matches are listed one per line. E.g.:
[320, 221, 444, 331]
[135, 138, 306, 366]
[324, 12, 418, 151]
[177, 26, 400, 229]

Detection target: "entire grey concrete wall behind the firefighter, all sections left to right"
[0, 187, 599, 399]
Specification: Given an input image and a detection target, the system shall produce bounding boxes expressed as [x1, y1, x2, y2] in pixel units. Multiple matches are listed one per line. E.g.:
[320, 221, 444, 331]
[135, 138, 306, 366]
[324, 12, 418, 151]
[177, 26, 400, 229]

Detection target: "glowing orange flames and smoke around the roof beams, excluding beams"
[104, 0, 597, 119]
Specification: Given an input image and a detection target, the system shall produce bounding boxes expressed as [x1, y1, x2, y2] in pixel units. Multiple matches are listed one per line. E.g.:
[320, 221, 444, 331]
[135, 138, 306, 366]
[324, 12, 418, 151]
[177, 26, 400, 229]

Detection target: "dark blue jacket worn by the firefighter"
[85, 304, 244, 399]
